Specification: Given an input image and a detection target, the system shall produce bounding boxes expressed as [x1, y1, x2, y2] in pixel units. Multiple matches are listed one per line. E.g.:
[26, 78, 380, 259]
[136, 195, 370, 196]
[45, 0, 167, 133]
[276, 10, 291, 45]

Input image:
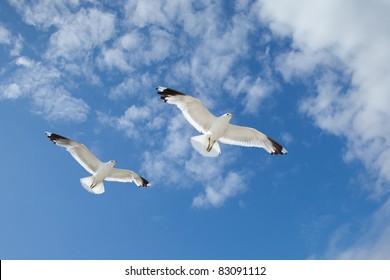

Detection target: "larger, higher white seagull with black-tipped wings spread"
[156, 86, 287, 157]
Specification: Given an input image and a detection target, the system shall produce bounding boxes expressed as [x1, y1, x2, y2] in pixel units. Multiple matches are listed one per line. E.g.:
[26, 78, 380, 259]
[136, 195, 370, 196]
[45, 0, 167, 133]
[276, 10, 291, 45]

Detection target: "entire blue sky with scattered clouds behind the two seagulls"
[0, 0, 390, 259]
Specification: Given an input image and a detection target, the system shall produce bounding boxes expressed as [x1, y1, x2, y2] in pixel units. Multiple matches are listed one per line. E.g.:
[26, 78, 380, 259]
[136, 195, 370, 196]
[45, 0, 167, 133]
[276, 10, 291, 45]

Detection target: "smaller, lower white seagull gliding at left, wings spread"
[45, 132, 150, 194]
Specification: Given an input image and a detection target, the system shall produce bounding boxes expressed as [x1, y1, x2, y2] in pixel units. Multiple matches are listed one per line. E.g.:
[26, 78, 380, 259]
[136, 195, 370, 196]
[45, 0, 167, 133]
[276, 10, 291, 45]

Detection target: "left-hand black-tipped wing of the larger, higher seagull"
[156, 86, 216, 133]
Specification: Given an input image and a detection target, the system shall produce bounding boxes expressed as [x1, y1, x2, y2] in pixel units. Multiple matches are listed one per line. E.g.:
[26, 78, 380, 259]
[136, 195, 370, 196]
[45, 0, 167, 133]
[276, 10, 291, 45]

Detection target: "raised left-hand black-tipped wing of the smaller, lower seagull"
[45, 132, 102, 174]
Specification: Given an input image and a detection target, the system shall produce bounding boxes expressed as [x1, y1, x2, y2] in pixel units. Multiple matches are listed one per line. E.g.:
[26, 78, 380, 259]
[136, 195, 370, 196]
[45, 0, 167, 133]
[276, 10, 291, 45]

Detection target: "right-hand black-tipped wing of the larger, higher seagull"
[219, 124, 287, 155]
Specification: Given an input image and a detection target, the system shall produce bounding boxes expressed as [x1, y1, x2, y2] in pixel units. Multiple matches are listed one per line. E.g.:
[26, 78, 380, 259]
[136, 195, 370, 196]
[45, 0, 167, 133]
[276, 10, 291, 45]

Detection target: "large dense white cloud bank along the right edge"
[258, 0, 390, 258]
